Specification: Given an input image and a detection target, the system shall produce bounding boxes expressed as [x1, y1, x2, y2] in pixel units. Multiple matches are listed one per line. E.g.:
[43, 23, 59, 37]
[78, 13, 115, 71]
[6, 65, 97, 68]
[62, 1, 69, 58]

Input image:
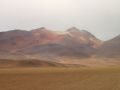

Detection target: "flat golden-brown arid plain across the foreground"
[0, 67, 120, 90]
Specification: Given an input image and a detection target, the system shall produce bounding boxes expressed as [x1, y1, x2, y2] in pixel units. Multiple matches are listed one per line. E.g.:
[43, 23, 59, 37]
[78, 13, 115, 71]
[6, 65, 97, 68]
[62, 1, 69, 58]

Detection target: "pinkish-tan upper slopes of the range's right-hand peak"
[67, 27, 101, 48]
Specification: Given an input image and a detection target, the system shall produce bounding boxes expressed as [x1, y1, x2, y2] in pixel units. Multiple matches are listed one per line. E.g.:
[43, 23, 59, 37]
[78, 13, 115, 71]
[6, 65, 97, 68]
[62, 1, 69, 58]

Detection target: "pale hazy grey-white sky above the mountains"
[0, 0, 120, 40]
